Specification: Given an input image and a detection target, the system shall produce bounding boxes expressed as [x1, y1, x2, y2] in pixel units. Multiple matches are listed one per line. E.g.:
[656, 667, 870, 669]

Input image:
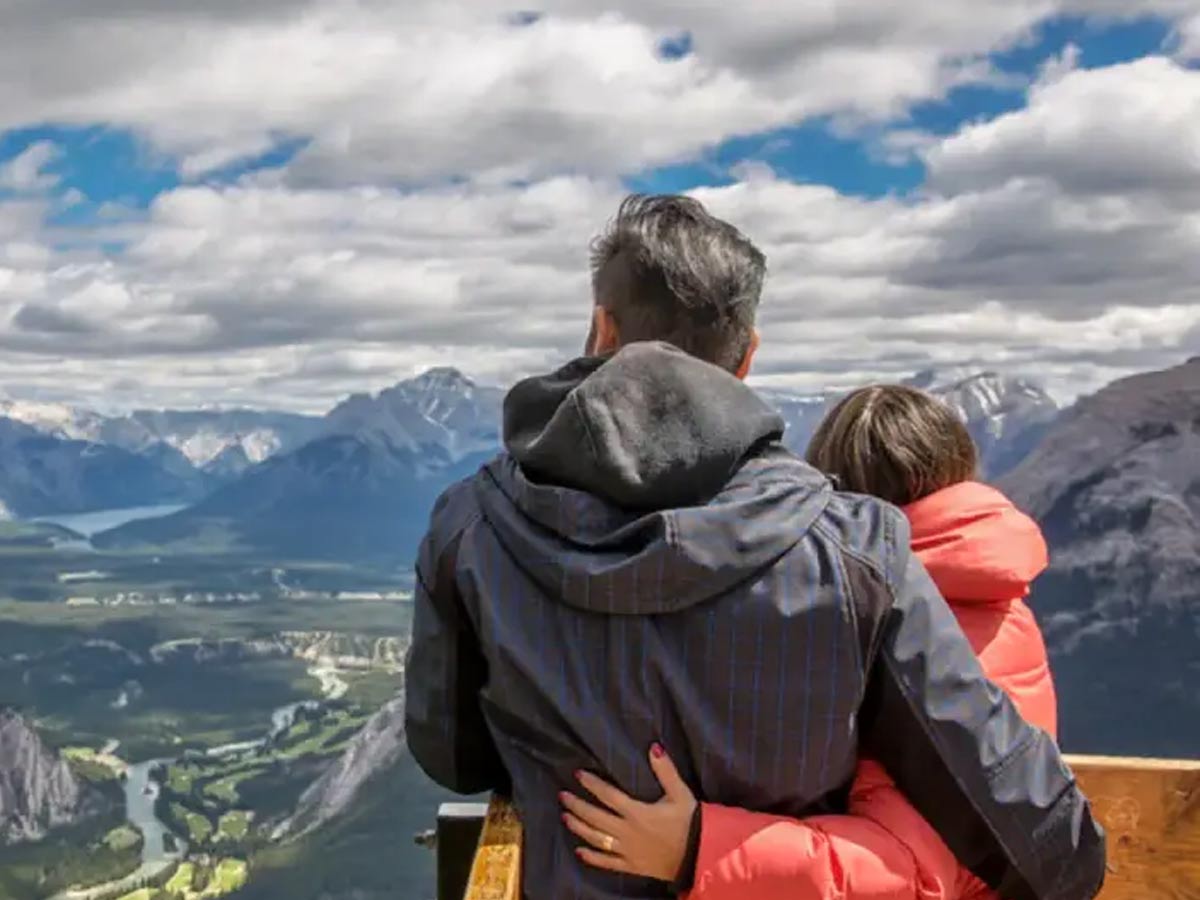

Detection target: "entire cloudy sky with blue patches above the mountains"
[0, 0, 1200, 409]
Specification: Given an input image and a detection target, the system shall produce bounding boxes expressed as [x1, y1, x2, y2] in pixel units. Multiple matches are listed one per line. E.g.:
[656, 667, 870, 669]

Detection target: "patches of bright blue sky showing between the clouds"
[0, 12, 1174, 211]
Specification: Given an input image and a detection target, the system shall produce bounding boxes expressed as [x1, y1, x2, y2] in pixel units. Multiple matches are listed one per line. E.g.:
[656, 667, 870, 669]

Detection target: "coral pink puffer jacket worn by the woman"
[689, 482, 1057, 900]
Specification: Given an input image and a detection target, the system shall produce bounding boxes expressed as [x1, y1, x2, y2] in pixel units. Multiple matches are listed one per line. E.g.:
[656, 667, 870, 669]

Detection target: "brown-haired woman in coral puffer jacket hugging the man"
[562, 385, 1057, 900]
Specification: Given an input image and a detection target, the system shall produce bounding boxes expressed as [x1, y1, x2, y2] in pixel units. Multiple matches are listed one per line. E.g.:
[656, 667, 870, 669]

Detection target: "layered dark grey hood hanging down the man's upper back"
[479, 343, 832, 614]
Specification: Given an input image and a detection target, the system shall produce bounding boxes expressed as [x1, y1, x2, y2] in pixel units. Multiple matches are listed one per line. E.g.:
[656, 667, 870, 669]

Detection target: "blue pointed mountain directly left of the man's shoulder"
[96, 370, 503, 565]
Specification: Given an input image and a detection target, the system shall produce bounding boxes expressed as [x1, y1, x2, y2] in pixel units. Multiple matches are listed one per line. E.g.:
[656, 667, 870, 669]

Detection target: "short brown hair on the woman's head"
[808, 384, 979, 506]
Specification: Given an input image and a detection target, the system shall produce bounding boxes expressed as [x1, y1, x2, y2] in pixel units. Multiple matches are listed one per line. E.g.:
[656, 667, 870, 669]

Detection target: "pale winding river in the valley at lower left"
[50, 666, 348, 900]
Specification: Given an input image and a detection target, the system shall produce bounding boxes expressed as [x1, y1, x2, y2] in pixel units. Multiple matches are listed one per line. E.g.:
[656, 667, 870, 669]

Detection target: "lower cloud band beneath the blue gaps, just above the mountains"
[0, 138, 1200, 409]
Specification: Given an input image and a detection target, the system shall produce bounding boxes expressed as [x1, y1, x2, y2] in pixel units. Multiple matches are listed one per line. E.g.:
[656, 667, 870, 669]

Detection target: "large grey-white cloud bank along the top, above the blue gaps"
[0, 0, 1194, 186]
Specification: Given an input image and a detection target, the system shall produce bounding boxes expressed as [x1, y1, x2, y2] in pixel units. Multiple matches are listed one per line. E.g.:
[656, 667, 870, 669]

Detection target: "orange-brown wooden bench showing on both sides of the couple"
[438, 756, 1200, 900]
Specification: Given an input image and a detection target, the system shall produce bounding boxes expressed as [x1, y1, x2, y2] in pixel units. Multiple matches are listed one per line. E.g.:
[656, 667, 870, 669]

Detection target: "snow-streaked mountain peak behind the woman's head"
[760, 368, 1058, 480]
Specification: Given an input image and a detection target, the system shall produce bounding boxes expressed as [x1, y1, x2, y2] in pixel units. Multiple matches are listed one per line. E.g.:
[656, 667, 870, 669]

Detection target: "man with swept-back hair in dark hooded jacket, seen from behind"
[406, 197, 1104, 900]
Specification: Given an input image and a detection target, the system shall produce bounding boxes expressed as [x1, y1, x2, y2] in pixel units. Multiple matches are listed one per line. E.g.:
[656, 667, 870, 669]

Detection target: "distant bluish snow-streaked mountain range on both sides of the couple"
[7, 367, 1057, 562]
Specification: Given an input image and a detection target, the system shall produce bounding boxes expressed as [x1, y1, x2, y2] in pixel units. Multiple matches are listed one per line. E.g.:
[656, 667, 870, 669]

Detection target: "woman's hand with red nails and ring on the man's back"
[559, 744, 696, 882]
